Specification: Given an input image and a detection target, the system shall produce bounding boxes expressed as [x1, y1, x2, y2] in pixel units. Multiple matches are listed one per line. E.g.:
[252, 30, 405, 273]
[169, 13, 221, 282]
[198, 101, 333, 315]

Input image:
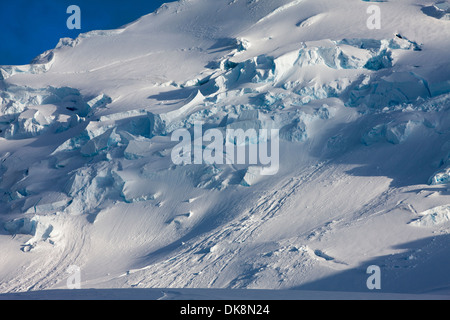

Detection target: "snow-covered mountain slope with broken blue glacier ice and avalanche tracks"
[0, 0, 450, 294]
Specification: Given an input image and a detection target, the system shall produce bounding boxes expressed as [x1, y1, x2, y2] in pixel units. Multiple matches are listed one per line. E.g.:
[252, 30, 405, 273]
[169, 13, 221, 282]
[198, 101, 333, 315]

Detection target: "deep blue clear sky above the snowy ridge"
[0, 0, 169, 65]
